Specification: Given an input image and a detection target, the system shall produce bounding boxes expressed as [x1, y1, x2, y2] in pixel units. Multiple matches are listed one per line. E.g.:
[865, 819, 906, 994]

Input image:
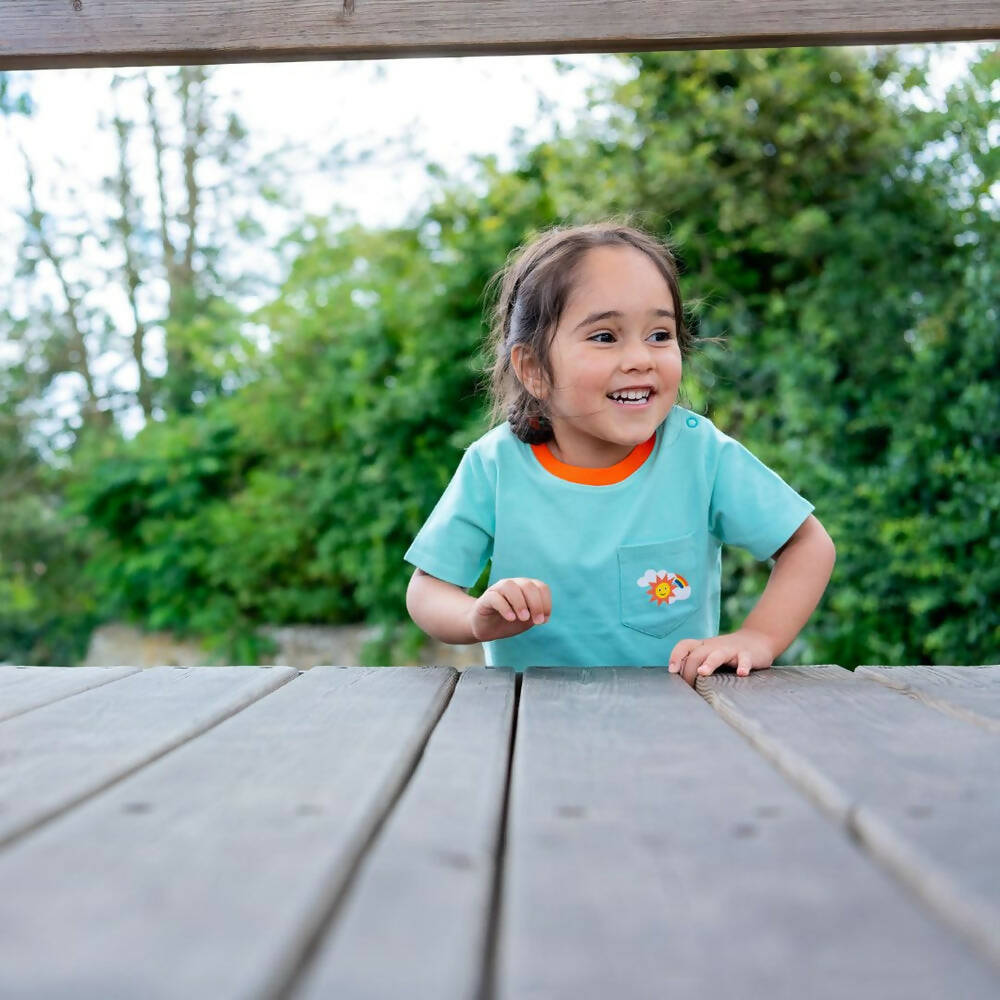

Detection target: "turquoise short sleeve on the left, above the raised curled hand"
[403, 448, 496, 587]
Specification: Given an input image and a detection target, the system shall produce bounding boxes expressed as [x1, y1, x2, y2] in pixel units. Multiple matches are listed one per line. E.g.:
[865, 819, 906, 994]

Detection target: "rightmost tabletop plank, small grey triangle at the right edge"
[854, 664, 1000, 733]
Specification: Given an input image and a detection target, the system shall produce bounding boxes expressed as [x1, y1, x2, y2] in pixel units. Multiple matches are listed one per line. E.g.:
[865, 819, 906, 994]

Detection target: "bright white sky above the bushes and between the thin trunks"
[0, 55, 629, 340]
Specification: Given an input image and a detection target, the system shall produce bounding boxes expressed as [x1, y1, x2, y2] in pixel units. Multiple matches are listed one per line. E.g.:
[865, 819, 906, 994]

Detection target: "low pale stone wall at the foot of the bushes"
[83, 625, 484, 670]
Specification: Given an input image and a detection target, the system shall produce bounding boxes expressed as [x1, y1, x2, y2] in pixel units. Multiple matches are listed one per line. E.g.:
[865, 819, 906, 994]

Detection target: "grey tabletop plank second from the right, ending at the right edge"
[698, 666, 1000, 969]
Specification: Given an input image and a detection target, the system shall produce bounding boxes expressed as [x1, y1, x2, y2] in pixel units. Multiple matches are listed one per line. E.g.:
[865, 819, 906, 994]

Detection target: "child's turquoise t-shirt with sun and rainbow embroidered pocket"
[404, 406, 814, 672]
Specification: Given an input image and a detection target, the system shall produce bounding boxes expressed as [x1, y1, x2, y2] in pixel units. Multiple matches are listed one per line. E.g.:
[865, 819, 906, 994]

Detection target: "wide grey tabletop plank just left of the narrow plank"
[0, 667, 457, 1000]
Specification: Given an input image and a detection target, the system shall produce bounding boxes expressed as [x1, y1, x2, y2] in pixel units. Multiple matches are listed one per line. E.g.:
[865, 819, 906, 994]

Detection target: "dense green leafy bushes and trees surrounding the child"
[0, 49, 1000, 667]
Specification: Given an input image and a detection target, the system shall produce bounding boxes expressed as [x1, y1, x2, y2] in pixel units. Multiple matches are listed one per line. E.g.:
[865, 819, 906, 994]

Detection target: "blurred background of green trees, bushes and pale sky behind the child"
[0, 44, 1000, 668]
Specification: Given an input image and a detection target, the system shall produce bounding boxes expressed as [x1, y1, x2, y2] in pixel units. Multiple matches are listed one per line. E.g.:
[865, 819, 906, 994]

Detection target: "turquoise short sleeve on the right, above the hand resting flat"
[709, 435, 815, 559]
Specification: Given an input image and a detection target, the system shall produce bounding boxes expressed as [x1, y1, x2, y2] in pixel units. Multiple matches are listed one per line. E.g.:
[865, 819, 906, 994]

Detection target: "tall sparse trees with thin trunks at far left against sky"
[0, 67, 292, 663]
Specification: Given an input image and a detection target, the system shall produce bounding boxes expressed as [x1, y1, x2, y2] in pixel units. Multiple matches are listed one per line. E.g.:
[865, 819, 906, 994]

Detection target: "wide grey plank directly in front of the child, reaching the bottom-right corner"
[496, 668, 1000, 1000]
